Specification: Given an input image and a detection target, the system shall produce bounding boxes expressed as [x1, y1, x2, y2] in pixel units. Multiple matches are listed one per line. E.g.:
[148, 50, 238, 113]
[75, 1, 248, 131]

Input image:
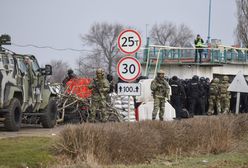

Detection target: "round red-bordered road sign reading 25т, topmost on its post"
[118, 29, 141, 55]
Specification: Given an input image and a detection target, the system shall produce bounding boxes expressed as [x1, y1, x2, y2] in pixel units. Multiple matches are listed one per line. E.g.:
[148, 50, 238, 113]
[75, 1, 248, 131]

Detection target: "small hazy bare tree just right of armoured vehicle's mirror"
[49, 60, 69, 83]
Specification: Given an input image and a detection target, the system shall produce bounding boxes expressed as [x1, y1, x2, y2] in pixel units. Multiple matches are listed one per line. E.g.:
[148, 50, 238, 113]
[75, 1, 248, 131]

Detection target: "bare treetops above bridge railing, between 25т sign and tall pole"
[150, 22, 193, 47]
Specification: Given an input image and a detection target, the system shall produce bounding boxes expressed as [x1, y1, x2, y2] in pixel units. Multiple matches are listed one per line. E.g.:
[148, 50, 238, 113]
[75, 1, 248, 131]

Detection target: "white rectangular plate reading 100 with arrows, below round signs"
[117, 83, 141, 96]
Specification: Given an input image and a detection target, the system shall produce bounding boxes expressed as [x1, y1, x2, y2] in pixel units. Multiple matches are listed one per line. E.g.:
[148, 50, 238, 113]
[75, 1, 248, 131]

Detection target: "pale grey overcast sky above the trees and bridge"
[0, 0, 237, 68]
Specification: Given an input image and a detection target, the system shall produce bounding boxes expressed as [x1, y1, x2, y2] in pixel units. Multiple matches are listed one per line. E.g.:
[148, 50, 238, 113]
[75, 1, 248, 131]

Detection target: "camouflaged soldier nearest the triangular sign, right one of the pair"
[220, 76, 231, 114]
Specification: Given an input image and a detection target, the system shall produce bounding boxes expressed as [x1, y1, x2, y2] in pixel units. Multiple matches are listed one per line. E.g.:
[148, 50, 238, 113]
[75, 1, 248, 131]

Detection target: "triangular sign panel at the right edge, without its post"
[227, 72, 248, 93]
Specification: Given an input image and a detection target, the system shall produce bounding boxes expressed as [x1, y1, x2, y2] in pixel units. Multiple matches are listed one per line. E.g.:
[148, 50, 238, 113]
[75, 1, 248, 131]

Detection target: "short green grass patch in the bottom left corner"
[0, 137, 54, 168]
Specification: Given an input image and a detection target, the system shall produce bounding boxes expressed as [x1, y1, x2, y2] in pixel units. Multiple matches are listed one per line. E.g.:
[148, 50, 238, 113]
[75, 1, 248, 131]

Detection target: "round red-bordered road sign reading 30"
[117, 56, 141, 82]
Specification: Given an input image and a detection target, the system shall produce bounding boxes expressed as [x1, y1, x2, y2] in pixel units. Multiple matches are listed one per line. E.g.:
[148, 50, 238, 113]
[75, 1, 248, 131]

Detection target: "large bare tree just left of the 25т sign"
[82, 22, 123, 74]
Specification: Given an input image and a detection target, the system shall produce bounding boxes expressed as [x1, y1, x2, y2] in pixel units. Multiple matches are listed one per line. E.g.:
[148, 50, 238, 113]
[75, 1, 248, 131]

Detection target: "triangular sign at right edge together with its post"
[227, 72, 248, 114]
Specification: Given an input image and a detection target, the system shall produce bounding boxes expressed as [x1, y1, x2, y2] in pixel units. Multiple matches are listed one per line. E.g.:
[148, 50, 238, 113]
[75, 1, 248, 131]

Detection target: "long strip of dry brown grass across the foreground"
[55, 115, 248, 167]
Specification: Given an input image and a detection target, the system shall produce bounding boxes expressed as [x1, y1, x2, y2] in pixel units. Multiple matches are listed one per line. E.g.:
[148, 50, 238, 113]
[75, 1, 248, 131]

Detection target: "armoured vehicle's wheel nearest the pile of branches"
[40, 99, 58, 128]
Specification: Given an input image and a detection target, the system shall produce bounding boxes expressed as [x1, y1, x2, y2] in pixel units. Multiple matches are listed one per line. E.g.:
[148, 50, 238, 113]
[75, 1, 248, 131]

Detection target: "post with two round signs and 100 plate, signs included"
[117, 29, 141, 121]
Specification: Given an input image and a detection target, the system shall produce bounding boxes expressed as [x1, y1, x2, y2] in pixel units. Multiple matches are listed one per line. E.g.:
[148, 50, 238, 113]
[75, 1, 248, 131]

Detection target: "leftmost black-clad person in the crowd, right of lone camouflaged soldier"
[169, 76, 186, 119]
